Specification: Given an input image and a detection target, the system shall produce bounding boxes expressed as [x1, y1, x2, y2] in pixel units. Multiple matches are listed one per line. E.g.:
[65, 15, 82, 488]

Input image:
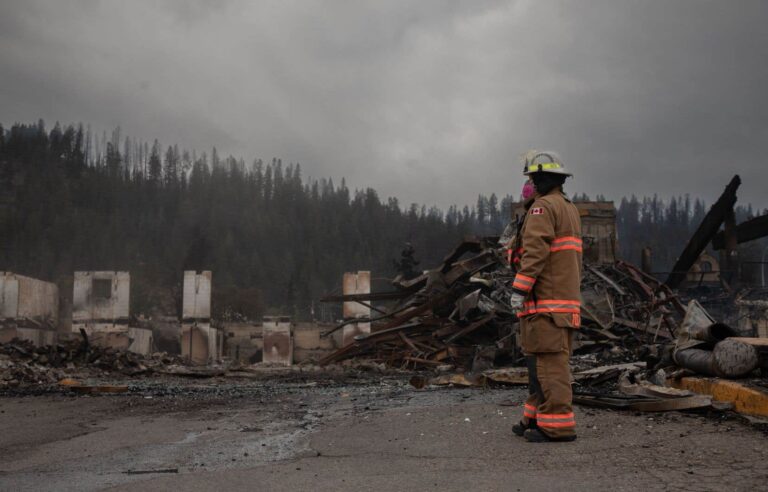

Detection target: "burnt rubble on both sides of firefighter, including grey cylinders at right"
[321, 237, 768, 410]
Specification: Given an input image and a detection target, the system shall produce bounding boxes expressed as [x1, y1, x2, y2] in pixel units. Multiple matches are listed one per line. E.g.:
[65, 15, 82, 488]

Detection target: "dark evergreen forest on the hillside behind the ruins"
[0, 121, 764, 318]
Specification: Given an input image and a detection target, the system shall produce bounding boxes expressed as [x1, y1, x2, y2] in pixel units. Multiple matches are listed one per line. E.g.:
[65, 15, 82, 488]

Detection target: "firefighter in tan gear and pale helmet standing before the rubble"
[510, 151, 582, 442]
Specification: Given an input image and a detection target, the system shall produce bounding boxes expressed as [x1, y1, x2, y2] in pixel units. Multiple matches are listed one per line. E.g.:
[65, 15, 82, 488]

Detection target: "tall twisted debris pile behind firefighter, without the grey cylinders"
[322, 237, 685, 372]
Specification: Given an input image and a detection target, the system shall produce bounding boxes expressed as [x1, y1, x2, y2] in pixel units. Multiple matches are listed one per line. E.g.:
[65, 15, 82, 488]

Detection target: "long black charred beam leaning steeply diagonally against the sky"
[664, 175, 741, 289]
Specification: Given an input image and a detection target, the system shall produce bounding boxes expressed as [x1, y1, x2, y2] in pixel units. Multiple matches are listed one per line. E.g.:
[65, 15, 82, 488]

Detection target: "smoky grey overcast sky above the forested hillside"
[0, 0, 768, 207]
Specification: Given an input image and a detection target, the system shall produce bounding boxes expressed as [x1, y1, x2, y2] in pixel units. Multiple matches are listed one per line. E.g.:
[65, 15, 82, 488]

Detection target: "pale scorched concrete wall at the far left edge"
[0, 272, 59, 328]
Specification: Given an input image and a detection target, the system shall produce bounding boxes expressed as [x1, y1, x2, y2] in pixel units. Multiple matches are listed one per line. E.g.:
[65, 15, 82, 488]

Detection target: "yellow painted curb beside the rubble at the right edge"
[668, 378, 768, 417]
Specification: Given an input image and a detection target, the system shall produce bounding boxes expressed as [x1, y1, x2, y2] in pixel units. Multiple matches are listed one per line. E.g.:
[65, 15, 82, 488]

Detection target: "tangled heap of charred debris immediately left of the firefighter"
[321, 238, 518, 369]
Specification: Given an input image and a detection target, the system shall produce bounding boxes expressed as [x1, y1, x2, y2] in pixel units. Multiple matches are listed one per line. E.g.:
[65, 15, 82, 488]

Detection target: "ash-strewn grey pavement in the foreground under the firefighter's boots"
[0, 371, 768, 491]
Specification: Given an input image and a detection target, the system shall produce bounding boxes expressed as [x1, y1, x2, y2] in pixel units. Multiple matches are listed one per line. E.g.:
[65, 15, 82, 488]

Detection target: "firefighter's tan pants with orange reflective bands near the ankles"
[520, 314, 576, 438]
